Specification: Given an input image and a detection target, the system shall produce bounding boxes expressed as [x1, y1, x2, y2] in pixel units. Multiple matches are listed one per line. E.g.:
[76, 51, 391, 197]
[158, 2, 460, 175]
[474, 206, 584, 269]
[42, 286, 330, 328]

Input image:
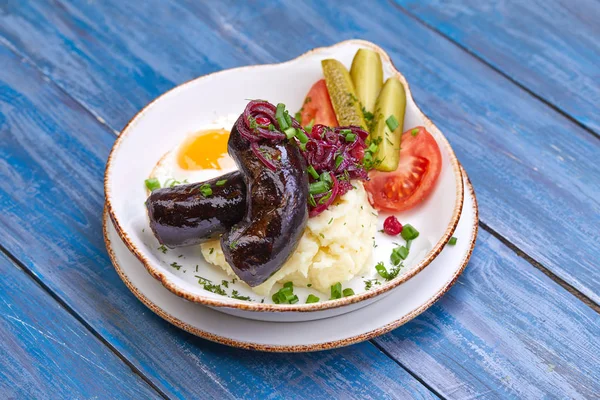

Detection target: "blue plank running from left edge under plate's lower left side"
[0, 38, 435, 399]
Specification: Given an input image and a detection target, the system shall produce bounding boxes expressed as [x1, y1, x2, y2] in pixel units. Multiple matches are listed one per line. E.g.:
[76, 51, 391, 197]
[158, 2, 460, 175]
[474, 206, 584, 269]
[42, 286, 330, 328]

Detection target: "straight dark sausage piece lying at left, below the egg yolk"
[146, 171, 246, 248]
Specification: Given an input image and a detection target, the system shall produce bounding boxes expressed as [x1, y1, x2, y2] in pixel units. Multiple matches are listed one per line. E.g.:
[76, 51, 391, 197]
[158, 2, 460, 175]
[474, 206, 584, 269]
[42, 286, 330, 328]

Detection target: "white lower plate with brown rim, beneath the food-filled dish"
[104, 170, 479, 352]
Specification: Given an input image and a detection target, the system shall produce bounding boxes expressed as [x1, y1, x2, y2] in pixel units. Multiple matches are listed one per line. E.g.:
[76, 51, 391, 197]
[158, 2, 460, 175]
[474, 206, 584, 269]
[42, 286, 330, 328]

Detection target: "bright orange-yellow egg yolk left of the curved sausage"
[177, 129, 229, 170]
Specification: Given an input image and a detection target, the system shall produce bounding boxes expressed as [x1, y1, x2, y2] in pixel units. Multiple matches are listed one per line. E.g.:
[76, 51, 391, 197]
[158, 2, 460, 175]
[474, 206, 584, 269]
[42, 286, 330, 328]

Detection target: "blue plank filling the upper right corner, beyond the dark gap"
[395, 0, 600, 134]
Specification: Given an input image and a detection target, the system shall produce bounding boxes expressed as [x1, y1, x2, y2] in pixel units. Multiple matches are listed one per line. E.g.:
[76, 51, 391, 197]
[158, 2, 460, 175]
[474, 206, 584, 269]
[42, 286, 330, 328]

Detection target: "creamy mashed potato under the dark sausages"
[201, 182, 377, 296]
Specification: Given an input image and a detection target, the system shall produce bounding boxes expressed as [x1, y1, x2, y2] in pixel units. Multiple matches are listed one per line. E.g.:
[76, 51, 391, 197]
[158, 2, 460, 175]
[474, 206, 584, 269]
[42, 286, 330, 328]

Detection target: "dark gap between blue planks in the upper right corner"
[388, 0, 600, 142]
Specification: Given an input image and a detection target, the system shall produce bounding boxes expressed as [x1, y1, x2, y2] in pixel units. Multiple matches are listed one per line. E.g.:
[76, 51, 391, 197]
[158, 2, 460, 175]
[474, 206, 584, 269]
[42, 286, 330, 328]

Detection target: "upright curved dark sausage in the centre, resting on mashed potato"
[221, 120, 308, 286]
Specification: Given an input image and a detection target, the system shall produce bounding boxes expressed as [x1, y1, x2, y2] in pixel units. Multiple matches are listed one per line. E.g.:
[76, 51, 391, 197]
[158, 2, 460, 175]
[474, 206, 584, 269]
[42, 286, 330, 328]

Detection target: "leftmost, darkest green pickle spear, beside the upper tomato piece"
[321, 59, 367, 129]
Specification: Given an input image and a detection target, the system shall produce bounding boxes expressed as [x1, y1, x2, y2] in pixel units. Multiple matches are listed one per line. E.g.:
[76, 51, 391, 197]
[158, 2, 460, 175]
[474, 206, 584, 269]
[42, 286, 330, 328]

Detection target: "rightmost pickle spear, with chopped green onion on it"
[371, 78, 406, 171]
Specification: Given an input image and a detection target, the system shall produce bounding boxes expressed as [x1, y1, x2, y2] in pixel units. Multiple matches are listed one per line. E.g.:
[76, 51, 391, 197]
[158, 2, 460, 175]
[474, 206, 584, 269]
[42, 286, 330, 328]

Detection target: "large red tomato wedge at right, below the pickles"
[366, 126, 442, 212]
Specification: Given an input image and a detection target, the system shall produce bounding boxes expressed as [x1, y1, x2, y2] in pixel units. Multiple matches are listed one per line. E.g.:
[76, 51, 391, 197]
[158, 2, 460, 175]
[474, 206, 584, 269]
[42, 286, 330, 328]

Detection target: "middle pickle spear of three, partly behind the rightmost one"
[350, 49, 383, 117]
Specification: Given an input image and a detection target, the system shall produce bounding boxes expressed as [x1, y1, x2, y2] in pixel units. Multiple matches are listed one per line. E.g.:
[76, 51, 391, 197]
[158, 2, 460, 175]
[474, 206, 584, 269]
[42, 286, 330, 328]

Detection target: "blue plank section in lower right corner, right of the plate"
[375, 231, 600, 399]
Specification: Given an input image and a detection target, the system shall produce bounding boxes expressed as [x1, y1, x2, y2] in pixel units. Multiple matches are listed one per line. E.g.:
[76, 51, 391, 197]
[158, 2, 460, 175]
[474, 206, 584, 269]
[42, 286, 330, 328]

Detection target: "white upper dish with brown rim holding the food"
[105, 40, 463, 321]
